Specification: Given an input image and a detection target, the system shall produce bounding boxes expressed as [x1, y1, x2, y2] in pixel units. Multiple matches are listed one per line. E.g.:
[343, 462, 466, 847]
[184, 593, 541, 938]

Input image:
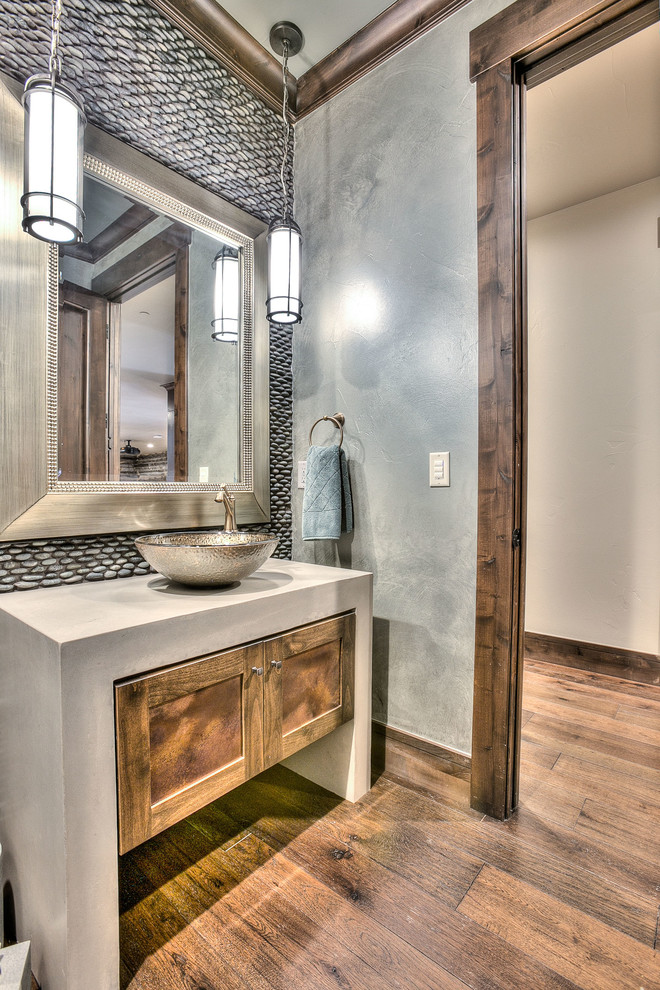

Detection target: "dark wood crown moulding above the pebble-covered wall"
[149, 0, 296, 112]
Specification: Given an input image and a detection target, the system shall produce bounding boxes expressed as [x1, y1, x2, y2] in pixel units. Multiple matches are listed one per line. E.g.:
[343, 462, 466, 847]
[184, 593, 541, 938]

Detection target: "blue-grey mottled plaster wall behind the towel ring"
[294, 0, 507, 752]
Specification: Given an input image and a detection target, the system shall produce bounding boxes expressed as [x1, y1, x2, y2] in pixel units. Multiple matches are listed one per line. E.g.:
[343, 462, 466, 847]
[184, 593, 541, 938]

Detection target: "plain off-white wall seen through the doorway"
[526, 178, 660, 653]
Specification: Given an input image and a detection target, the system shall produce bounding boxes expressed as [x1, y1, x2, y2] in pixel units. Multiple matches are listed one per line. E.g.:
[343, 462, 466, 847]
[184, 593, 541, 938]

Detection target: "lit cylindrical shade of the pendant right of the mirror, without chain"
[266, 219, 302, 326]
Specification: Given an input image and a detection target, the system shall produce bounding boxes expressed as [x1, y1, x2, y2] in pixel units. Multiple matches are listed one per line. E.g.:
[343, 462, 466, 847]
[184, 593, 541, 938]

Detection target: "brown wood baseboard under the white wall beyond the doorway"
[525, 632, 660, 684]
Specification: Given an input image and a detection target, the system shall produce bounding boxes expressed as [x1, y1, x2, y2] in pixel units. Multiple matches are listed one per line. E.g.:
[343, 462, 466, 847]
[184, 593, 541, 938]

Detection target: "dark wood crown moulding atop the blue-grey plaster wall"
[296, 0, 470, 119]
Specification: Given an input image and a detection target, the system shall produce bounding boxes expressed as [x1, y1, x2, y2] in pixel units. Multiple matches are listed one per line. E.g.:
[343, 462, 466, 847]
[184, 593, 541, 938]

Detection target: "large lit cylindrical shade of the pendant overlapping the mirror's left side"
[21, 76, 87, 244]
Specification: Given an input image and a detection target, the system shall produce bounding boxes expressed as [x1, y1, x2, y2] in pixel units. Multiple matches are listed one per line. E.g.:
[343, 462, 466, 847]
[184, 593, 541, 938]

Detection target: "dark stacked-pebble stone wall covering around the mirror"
[0, 0, 292, 592]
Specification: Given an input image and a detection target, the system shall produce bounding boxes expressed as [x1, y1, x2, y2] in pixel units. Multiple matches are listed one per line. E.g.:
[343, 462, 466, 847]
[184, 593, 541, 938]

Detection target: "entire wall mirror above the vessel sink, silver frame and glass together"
[0, 70, 270, 540]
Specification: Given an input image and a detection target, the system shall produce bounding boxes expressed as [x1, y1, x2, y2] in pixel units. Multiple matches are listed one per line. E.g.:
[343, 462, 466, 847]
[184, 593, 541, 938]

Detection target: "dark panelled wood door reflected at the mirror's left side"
[57, 282, 108, 481]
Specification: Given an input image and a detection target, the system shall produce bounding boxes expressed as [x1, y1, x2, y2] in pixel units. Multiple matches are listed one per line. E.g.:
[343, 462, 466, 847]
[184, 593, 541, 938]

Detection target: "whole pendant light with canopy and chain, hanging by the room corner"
[266, 21, 303, 326]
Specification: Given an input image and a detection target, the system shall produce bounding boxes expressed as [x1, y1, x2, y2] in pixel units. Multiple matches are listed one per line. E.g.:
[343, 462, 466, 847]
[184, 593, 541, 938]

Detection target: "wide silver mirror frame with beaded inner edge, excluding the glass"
[0, 72, 270, 541]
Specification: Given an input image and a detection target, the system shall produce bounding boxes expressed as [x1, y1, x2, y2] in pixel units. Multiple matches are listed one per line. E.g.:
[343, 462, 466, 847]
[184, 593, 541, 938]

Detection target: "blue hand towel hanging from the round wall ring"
[302, 444, 353, 540]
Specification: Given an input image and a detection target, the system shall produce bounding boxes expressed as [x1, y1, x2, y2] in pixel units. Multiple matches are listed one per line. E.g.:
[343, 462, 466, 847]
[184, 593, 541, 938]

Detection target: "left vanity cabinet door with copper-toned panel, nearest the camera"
[115, 643, 263, 853]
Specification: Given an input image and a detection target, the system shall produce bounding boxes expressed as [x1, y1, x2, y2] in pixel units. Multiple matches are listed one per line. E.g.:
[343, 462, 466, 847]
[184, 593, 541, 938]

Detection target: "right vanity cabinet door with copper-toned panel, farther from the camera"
[264, 613, 355, 766]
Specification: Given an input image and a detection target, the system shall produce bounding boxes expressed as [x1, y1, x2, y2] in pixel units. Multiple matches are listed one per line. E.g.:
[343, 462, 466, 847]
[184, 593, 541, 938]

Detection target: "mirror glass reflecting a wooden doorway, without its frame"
[57, 174, 241, 484]
